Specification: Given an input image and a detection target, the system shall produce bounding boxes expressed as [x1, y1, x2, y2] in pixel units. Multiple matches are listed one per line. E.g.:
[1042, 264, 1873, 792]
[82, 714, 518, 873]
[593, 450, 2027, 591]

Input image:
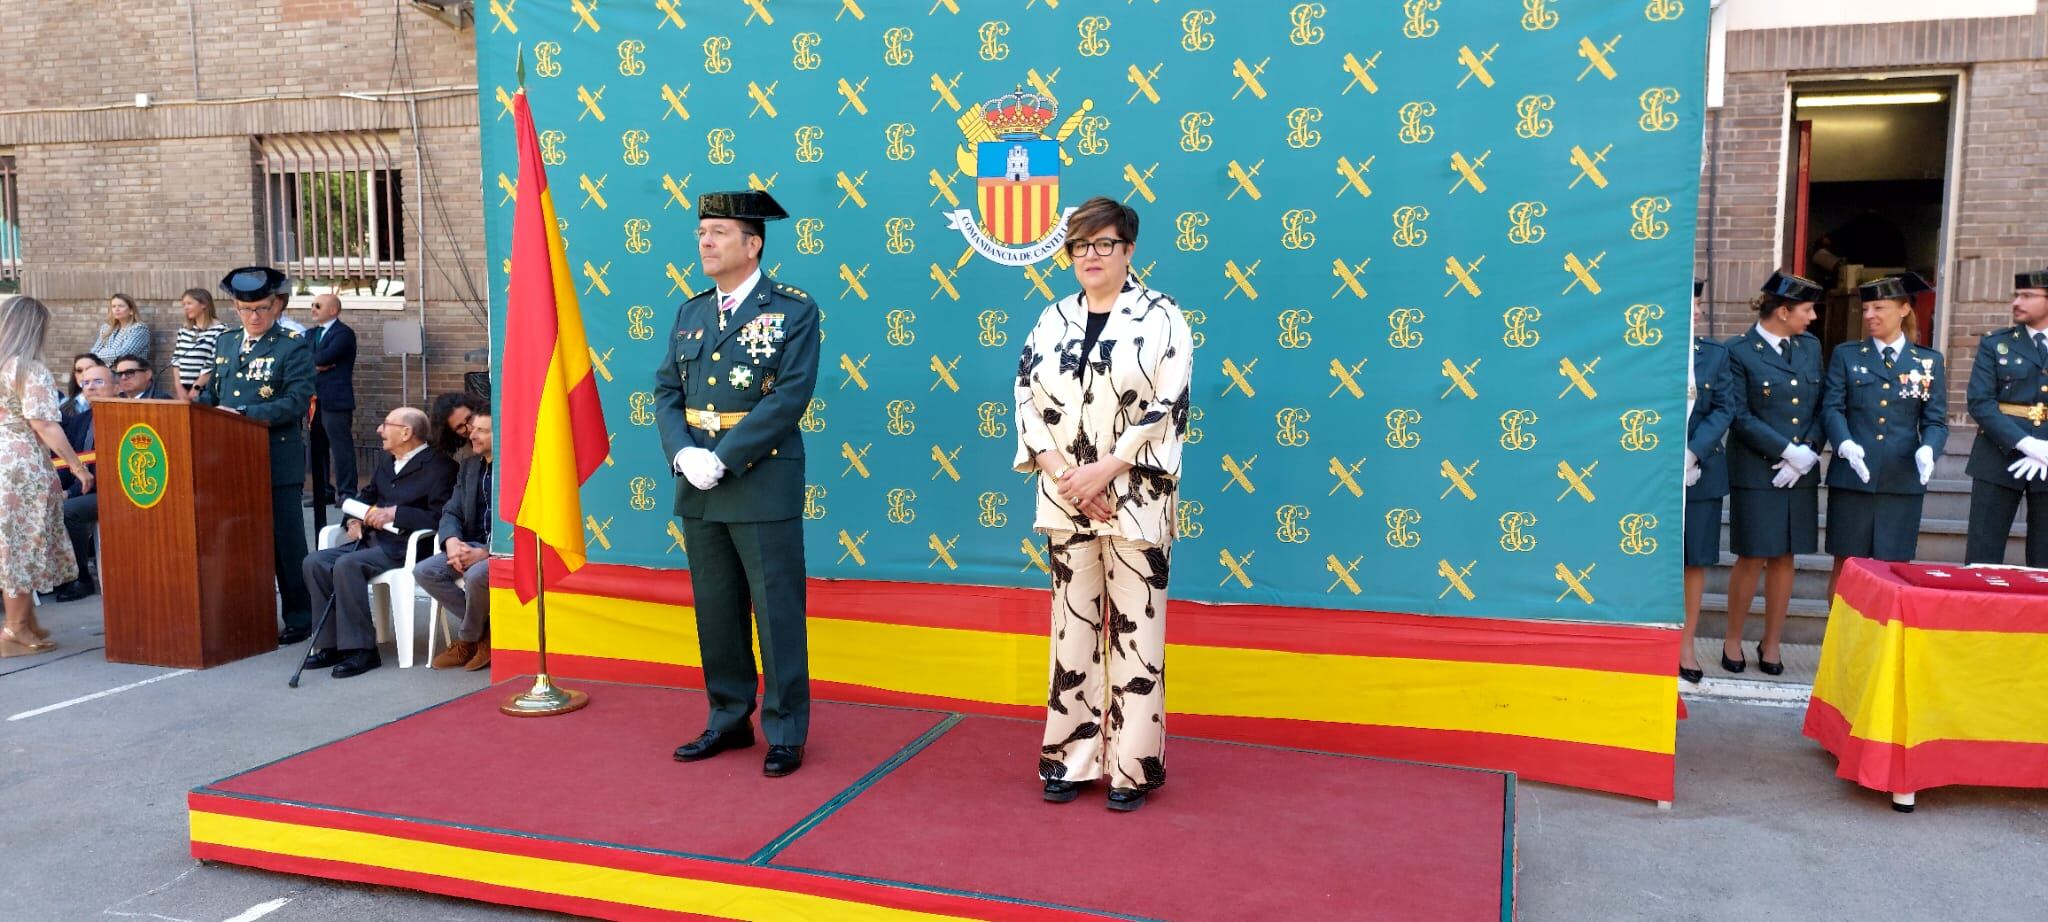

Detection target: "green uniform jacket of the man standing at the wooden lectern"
[193, 326, 313, 486]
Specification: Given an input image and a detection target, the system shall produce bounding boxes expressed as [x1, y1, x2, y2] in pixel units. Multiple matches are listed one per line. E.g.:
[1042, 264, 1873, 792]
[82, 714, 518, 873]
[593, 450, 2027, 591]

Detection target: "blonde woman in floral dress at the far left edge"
[0, 295, 92, 658]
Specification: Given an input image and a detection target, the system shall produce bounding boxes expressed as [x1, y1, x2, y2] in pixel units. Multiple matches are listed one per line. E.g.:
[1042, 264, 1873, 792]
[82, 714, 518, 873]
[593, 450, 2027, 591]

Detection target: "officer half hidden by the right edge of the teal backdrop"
[1677, 281, 1735, 684]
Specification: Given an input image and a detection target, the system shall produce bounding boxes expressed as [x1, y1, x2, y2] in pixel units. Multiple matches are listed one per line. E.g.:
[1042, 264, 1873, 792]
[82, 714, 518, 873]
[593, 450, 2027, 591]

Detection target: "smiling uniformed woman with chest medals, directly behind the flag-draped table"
[1821, 273, 1948, 596]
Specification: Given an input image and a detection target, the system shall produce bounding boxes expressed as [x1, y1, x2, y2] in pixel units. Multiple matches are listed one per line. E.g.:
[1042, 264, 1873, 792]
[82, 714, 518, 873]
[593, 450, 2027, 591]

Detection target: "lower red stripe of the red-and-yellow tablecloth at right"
[1802, 699, 2048, 793]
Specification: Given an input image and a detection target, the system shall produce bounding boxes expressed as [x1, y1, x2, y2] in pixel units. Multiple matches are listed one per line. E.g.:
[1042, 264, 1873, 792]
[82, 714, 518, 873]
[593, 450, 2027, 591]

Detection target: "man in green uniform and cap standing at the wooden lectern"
[193, 266, 313, 645]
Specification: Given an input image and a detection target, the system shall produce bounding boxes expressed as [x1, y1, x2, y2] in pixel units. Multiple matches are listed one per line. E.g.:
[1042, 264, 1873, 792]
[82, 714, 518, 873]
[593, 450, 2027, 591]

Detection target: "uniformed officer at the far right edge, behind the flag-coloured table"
[1964, 270, 2048, 568]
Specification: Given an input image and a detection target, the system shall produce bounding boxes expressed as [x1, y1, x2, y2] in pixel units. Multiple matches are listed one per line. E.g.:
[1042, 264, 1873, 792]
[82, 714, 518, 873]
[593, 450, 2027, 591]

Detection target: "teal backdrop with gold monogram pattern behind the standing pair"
[477, 0, 1706, 621]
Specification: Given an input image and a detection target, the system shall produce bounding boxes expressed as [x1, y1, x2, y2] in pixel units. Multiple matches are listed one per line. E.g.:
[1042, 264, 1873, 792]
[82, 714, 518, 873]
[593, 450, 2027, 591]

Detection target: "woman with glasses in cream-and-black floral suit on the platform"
[1016, 197, 1194, 811]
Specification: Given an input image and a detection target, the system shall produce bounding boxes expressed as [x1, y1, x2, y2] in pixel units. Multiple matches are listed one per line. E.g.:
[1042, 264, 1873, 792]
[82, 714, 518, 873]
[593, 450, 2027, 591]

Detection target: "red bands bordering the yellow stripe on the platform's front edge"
[186, 791, 1100, 920]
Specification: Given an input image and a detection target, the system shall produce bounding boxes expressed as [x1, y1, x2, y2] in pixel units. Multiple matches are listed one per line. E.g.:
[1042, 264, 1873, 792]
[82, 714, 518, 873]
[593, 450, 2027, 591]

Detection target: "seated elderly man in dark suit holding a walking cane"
[303, 406, 455, 678]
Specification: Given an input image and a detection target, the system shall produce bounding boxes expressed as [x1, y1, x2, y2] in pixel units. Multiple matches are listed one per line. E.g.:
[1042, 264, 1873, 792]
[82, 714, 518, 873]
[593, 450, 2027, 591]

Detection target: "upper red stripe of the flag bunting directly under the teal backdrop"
[492, 559, 1677, 682]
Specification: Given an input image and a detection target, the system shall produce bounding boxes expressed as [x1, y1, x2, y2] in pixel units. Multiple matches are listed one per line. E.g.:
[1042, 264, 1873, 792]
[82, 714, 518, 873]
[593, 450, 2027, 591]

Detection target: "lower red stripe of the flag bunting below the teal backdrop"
[492, 649, 1675, 801]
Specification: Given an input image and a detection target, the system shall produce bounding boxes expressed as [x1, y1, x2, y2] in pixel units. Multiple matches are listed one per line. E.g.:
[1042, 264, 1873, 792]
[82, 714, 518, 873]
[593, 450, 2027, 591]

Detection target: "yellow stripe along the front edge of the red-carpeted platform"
[190, 811, 963, 922]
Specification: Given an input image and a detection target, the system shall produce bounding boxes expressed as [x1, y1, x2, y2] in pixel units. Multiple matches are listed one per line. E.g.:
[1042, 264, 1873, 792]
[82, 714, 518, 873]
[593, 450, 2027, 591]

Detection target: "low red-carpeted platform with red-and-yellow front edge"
[190, 682, 1513, 920]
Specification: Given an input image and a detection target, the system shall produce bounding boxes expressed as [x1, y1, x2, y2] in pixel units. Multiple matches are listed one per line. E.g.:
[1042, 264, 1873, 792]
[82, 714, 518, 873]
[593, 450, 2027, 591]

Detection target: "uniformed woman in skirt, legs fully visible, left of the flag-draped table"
[1720, 273, 1823, 676]
